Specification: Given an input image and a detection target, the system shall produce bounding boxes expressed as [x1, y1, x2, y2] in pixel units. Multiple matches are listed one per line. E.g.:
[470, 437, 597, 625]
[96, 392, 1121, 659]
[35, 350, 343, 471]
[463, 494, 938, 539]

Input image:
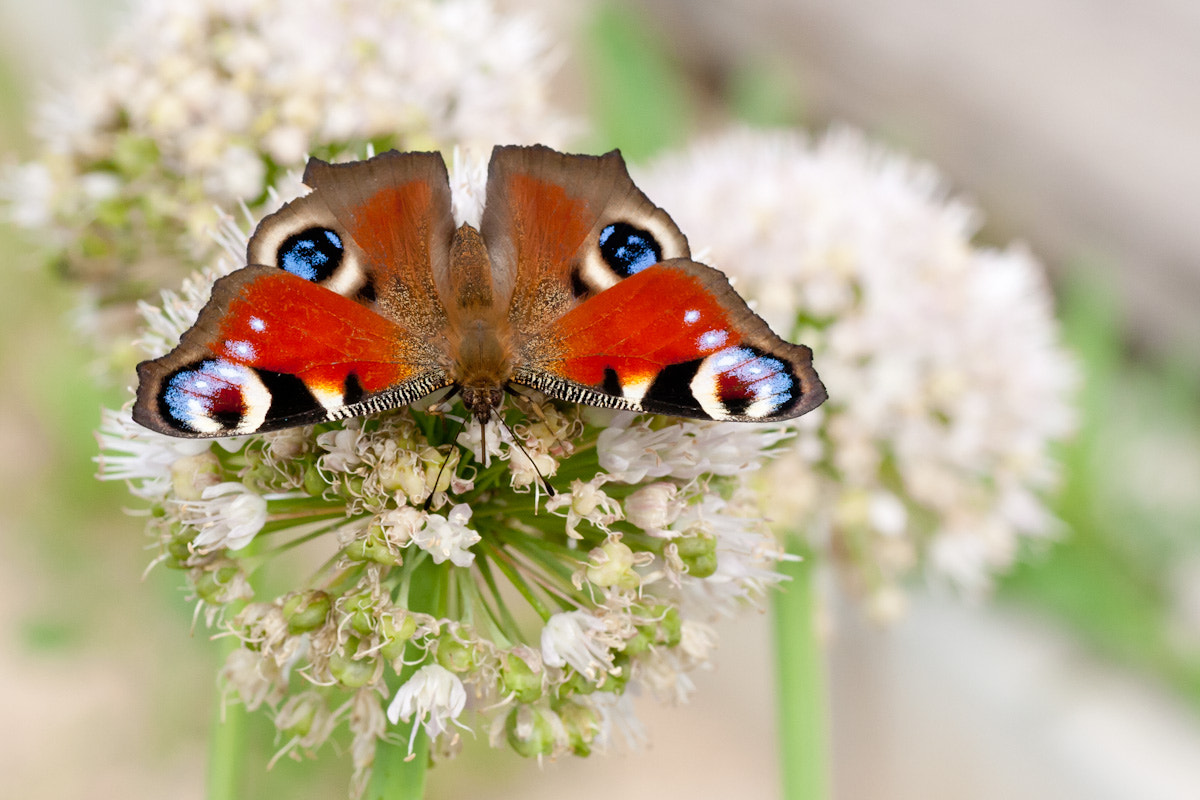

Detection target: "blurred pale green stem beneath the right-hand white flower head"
[772, 536, 829, 800]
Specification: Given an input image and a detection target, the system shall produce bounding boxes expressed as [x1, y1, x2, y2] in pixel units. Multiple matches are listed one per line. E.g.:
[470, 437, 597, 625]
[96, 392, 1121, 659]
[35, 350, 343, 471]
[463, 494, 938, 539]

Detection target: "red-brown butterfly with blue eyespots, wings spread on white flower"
[133, 145, 826, 438]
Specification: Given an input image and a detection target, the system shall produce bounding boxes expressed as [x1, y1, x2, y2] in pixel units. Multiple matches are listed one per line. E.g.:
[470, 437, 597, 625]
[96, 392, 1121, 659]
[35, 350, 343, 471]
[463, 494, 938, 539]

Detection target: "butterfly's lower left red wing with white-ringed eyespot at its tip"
[133, 266, 449, 437]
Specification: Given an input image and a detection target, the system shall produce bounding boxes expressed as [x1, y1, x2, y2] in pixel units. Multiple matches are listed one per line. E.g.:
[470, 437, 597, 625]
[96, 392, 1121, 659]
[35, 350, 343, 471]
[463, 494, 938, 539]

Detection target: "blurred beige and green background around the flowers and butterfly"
[0, 0, 1200, 800]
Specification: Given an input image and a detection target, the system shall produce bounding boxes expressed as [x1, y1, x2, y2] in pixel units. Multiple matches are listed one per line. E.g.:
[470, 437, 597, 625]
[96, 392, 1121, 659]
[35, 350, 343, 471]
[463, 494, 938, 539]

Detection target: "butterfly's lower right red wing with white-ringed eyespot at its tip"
[512, 259, 826, 422]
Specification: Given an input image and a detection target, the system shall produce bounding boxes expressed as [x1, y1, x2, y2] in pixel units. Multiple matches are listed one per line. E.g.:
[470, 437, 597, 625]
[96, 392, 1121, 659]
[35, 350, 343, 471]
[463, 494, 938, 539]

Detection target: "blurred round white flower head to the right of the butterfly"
[636, 130, 1076, 615]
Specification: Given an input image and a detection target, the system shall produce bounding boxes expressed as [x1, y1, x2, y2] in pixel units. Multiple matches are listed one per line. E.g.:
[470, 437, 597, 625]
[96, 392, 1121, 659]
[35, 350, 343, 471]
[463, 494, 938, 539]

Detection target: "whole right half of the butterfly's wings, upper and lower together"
[482, 148, 826, 422]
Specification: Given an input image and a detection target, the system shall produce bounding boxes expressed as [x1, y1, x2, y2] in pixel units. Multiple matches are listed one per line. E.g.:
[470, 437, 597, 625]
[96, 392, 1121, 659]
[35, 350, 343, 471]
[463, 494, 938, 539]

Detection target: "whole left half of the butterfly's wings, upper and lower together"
[133, 154, 454, 437]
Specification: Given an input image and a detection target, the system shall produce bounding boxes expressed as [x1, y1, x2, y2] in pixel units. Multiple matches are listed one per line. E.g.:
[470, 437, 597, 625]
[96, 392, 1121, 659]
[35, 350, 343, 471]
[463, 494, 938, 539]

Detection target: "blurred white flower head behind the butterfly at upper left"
[7, 0, 574, 352]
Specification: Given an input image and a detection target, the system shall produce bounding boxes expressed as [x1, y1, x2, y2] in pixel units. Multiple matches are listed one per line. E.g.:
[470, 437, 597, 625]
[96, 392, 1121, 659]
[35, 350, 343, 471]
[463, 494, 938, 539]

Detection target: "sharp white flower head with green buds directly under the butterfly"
[91, 155, 788, 781]
